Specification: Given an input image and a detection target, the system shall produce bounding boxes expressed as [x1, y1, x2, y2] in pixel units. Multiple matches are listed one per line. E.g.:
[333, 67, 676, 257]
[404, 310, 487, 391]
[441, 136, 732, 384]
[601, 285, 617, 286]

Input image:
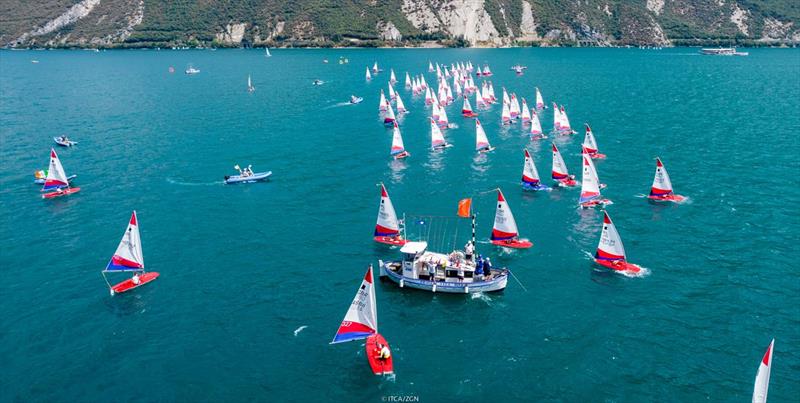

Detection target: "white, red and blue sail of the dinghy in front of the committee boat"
[331, 266, 378, 344]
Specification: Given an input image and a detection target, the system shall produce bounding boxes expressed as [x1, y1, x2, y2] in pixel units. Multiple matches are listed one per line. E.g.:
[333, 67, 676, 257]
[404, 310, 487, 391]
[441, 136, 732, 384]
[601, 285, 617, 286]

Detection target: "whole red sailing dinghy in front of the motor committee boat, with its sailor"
[331, 265, 394, 375]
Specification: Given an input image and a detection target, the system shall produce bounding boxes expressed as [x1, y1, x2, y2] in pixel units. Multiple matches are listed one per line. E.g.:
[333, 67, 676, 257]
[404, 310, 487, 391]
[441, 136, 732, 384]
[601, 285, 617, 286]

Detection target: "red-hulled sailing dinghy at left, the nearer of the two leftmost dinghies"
[102, 210, 158, 295]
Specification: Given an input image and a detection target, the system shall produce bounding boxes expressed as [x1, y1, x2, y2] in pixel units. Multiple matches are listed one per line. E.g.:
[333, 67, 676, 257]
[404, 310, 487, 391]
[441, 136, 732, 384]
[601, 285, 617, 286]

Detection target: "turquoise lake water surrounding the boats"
[0, 48, 800, 402]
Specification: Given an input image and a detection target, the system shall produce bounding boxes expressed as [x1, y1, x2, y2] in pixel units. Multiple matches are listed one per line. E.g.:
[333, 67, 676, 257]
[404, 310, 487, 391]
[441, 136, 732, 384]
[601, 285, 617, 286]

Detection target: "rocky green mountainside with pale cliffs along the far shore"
[0, 0, 800, 46]
